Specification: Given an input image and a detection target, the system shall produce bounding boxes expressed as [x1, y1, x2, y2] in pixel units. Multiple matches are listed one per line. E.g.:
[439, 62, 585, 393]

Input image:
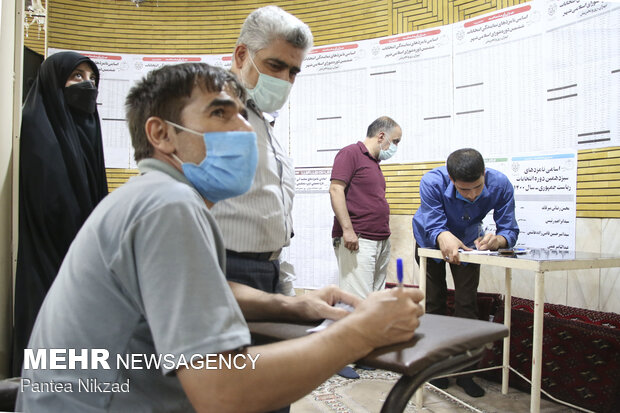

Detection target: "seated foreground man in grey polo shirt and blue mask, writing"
[17, 63, 423, 413]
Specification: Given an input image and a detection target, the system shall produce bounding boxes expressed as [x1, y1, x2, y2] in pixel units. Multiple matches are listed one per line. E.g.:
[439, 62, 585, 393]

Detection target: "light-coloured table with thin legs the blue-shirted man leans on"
[418, 248, 620, 413]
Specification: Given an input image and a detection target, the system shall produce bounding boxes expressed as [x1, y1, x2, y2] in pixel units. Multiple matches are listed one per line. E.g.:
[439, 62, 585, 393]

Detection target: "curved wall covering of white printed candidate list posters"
[49, 0, 620, 287]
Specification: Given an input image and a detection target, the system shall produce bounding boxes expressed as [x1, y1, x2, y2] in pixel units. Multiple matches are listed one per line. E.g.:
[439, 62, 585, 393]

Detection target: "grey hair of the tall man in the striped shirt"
[237, 6, 313, 56]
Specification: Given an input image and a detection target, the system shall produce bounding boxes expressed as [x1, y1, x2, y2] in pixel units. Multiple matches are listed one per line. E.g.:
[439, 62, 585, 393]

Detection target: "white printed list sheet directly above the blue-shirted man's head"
[451, 2, 545, 156]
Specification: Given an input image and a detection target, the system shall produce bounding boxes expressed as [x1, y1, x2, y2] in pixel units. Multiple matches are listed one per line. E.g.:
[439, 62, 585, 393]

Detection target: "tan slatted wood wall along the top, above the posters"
[26, 0, 524, 54]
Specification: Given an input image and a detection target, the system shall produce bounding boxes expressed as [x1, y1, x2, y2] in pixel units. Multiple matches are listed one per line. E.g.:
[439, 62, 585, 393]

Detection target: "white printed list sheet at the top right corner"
[544, 0, 620, 149]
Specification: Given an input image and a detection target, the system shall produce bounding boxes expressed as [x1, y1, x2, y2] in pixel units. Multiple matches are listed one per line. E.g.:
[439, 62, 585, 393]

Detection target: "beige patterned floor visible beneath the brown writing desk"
[291, 370, 577, 413]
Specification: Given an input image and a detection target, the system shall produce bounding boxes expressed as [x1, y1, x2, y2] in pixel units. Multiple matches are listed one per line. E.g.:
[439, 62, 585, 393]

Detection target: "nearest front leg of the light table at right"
[530, 271, 545, 413]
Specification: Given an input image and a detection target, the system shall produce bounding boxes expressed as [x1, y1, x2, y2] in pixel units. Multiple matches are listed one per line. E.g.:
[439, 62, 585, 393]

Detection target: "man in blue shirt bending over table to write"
[413, 148, 519, 397]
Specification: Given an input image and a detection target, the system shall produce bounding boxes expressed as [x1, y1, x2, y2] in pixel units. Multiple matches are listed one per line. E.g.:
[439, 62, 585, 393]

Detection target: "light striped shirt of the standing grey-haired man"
[211, 101, 295, 252]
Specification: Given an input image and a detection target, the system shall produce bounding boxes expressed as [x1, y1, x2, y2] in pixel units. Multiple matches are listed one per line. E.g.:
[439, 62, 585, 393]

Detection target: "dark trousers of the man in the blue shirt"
[415, 244, 480, 319]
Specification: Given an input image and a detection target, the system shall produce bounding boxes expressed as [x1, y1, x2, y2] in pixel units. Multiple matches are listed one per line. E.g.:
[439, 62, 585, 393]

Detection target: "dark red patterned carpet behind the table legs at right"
[480, 297, 620, 413]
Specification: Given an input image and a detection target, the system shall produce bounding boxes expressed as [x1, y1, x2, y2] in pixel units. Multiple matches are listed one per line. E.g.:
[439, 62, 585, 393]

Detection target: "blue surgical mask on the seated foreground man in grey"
[166, 121, 258, 202]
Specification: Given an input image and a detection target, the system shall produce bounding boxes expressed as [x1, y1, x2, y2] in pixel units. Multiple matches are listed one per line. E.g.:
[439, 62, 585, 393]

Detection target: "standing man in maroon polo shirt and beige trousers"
[329, 116, 402, 298]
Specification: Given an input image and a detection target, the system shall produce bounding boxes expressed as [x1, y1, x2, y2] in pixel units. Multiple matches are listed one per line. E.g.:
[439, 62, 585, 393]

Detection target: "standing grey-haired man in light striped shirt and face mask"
[213, 6, 313, 295]
